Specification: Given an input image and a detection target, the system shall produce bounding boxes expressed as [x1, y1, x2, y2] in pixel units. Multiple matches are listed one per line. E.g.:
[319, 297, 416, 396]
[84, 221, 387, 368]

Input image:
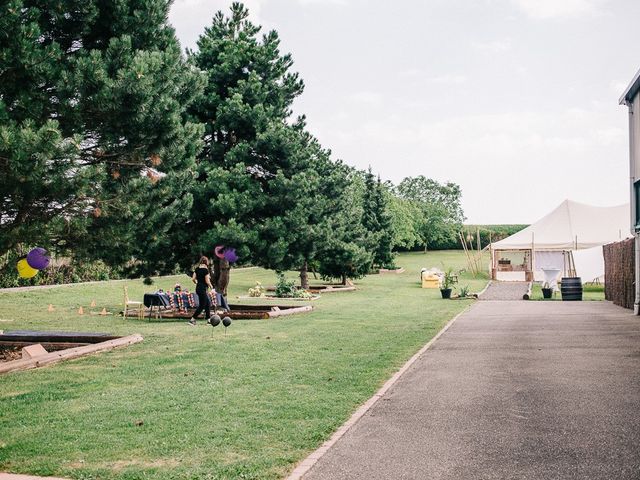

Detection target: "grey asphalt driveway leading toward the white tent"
[304, 301, 640, 480]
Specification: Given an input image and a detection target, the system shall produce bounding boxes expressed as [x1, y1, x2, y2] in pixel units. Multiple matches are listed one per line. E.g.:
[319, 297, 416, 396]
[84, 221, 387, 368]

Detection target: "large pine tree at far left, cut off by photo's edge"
[0, 0, 204, 270]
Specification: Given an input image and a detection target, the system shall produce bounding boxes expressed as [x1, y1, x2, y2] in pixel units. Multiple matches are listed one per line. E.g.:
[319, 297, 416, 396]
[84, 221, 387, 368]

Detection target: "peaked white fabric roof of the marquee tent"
[491, 200, 631, 250]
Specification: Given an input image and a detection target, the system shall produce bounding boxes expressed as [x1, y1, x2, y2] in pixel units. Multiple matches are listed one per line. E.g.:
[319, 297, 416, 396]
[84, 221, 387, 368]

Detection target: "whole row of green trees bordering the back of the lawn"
[0, 0, 464, 291]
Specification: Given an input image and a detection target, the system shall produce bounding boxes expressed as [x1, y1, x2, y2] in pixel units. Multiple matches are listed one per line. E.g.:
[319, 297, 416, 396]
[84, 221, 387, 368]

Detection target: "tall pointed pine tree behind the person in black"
[189, 3, 330, 291]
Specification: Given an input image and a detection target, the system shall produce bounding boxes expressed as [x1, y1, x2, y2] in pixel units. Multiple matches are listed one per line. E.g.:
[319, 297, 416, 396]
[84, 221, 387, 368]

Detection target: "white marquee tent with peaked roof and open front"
[491, 200, 631, 282]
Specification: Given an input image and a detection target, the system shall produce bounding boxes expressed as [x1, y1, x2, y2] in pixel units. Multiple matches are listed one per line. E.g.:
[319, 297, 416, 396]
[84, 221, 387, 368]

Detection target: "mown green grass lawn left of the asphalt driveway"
[0, 252, 486, 479]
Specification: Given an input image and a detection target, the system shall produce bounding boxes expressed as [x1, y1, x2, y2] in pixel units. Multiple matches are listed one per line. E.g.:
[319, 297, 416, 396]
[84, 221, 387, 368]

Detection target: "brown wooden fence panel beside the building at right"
[602, 238, 635, 309]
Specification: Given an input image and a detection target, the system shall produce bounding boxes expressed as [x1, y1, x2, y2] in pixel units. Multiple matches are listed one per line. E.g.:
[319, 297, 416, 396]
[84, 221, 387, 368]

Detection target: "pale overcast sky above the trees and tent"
[169, 0, 640, 224]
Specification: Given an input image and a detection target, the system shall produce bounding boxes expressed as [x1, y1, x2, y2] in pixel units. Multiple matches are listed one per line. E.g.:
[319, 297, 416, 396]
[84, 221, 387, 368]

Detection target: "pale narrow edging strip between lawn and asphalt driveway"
[284, 304, 473, 480]
